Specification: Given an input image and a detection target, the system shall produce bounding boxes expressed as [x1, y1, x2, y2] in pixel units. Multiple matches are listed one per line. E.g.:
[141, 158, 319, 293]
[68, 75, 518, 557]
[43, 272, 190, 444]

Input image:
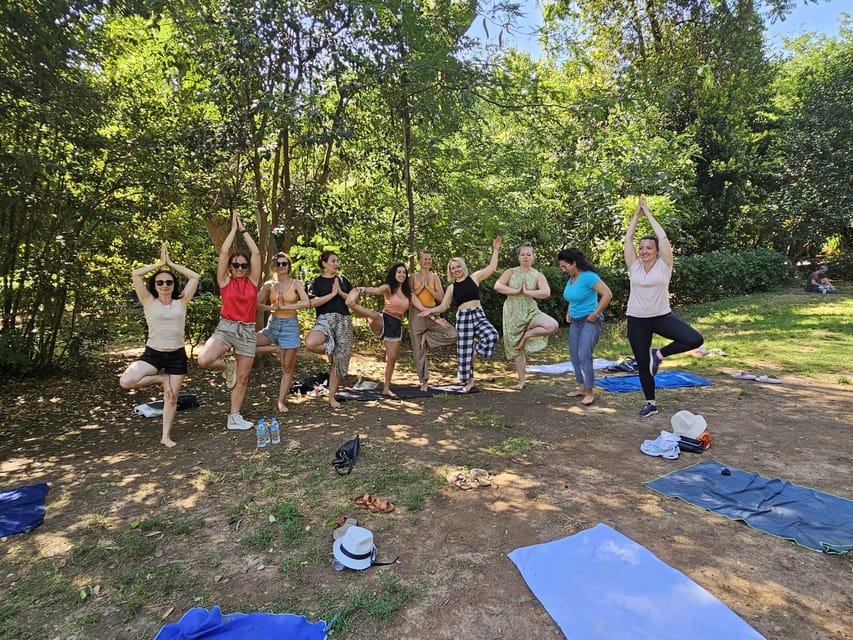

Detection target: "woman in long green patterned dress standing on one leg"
[495, 242, 560, 390]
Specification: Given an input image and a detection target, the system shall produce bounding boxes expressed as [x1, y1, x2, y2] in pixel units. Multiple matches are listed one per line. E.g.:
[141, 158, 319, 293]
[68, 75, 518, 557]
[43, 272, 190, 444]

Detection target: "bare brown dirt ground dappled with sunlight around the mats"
[0, 338, 853, 640]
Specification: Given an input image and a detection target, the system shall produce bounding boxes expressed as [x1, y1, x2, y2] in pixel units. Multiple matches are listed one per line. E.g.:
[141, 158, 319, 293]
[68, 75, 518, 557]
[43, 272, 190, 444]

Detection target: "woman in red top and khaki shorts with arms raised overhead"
[198, 213, 261, 430]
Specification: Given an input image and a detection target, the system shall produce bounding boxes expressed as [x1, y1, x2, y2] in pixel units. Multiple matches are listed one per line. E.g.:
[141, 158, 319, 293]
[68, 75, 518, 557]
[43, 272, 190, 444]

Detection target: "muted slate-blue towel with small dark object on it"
[646, 460, 853, 553]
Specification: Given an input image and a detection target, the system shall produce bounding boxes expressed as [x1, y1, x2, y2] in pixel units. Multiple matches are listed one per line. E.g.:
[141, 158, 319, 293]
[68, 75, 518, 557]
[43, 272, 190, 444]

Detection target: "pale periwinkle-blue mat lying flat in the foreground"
[509, 524, 762, 640]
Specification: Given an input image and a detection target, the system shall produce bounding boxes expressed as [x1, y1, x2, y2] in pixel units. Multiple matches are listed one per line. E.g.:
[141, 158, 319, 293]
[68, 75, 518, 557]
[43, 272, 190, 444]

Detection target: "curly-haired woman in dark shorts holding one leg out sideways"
[346, 262, 424, 398]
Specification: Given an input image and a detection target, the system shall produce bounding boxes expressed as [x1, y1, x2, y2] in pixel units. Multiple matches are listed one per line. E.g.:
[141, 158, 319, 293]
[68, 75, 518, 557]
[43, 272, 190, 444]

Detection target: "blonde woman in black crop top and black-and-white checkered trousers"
[421, 237, 502, 393]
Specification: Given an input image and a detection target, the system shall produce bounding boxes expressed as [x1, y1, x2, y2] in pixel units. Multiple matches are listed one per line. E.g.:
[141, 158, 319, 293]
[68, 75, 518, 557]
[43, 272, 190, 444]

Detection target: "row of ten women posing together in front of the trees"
[120, 197, 703, 447]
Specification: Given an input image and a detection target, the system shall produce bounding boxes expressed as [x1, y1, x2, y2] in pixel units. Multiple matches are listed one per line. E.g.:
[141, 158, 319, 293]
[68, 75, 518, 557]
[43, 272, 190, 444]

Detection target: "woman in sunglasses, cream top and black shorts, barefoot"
[119, 242, 201, 447]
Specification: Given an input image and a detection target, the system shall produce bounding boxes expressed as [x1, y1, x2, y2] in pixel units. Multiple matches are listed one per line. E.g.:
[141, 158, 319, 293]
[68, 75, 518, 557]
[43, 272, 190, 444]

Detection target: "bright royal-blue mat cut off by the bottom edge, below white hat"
[154, 607, 327, 640]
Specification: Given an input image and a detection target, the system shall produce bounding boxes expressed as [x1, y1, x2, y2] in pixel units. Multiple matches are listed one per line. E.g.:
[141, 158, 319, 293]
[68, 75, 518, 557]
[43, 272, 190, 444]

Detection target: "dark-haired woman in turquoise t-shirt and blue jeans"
[557, 249, 613, 405]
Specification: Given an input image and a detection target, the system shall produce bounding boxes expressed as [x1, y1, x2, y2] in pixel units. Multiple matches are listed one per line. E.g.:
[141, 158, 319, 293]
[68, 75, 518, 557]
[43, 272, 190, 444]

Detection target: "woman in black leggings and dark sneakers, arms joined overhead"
[625, 196, 704, 418]
